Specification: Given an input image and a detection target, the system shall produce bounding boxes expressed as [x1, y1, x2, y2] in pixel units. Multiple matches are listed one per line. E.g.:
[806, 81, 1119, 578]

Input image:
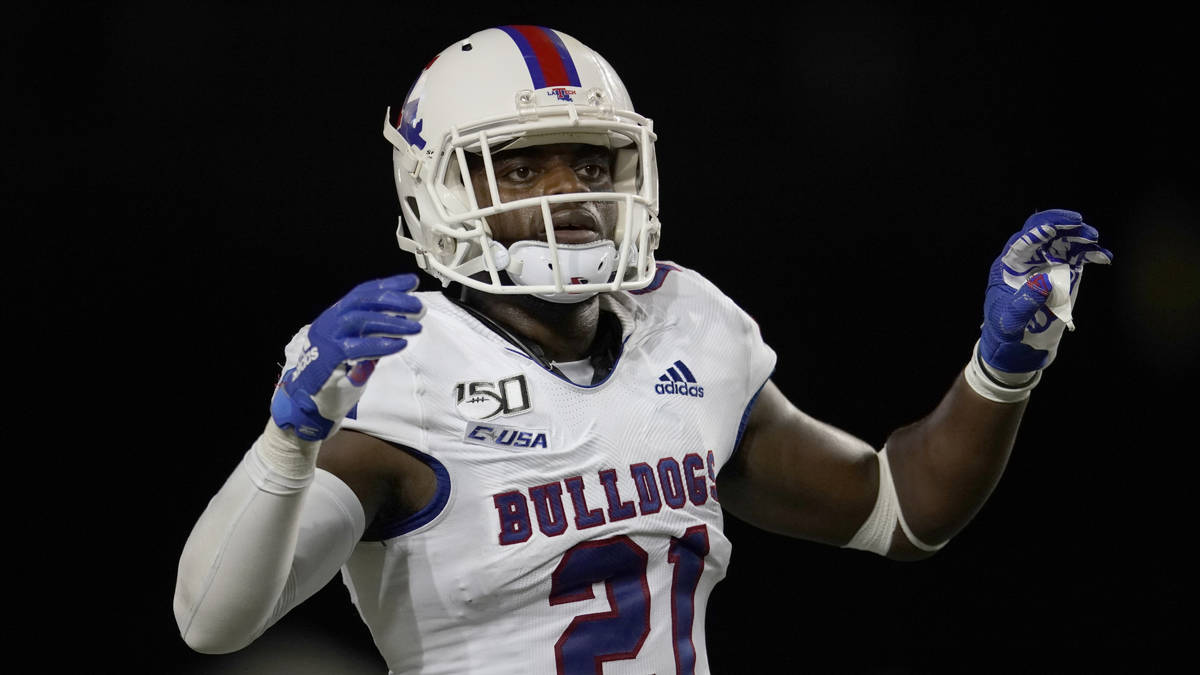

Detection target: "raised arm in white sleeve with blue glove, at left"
[174, 270, 424, 653]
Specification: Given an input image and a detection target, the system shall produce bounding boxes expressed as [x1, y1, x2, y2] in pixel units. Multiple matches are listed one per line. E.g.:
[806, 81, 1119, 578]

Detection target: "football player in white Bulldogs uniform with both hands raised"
[174, 25, 1111, 675]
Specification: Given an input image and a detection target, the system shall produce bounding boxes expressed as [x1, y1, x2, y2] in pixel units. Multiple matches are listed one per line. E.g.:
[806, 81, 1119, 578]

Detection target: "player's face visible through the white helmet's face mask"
[470, 143, 617, 246]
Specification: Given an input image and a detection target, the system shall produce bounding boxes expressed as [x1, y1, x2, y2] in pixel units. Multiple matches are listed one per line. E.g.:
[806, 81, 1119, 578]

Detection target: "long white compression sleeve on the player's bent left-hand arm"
[175, 423, 366, 653]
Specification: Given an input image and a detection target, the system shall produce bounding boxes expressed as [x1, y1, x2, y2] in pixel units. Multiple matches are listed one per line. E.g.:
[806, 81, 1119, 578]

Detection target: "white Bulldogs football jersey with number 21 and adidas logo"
[331, 263, 775, 675]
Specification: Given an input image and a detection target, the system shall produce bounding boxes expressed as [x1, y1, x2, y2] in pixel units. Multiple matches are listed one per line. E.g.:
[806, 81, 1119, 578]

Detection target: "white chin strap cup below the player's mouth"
[506, 239, 617, 304]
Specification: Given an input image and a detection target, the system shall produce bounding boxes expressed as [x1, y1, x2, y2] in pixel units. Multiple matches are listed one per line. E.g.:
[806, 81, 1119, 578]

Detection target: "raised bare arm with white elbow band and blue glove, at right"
[720, 209, 1112, 560]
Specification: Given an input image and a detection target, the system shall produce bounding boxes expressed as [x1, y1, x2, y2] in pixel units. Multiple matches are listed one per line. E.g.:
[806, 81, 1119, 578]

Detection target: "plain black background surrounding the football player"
[9, 1, 1200, 673]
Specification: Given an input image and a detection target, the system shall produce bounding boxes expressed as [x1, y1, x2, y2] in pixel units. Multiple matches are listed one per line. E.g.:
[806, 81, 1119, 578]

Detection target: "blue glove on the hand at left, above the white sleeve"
[271, 274, 425, 441]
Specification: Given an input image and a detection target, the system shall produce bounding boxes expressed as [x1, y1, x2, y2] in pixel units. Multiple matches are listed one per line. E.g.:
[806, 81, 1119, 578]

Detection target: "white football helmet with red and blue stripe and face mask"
[384, 25, 659, 303]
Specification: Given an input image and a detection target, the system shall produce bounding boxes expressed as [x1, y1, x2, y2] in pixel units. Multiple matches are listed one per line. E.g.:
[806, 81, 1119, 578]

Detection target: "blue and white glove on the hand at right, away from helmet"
[979, 209, 1112, 374]
